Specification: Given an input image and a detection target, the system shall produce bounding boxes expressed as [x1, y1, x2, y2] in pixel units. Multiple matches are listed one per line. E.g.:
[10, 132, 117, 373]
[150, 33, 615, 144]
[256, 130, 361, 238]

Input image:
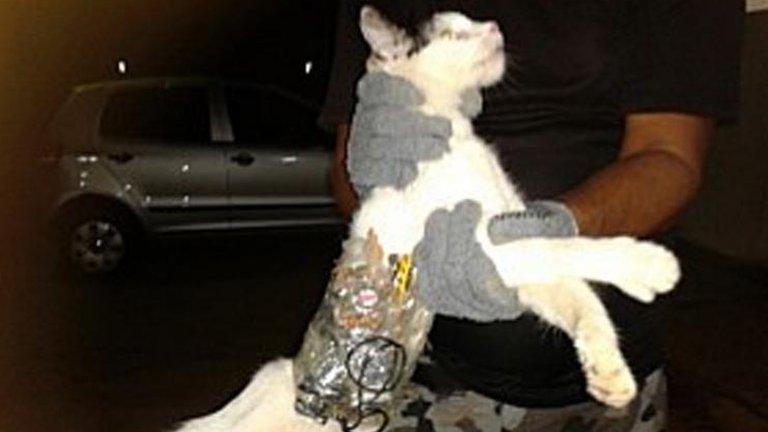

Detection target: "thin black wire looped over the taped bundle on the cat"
[338, 336, 407, 432]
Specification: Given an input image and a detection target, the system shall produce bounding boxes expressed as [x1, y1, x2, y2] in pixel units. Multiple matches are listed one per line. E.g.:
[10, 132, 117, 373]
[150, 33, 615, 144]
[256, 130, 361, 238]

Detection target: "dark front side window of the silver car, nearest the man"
[226, 88, 325, 147]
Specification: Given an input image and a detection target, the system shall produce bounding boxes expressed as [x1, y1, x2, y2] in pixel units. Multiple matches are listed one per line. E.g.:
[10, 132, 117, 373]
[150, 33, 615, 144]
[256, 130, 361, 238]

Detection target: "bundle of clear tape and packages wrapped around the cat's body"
[294, 232, 433, 430]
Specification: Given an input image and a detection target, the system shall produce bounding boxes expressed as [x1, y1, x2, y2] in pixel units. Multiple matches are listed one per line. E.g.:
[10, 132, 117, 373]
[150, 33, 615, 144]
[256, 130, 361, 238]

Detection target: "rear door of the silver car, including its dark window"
[99, 85, 228, 232]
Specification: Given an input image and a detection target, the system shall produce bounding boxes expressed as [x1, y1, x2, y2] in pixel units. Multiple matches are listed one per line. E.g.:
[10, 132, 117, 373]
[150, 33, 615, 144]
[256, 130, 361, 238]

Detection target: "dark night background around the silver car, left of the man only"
[0, 0, 341, 432]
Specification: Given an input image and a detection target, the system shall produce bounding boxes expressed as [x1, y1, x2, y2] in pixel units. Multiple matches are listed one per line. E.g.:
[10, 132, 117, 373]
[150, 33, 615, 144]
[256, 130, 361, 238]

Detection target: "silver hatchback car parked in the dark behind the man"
[49, 78, 340, 273]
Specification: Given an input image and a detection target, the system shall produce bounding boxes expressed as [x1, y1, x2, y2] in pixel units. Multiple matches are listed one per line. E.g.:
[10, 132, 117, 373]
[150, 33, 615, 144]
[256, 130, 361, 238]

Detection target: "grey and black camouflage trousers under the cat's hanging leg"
[387, 370, 667, 432]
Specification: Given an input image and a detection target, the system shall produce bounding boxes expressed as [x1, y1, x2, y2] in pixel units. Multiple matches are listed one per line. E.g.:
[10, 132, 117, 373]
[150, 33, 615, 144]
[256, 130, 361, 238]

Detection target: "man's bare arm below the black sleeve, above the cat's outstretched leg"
[561, 113, 715, 237]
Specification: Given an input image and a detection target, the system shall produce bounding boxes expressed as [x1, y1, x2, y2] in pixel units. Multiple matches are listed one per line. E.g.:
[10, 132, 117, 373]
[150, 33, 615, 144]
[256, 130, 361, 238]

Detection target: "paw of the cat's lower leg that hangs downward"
[580, 340, 637, 408]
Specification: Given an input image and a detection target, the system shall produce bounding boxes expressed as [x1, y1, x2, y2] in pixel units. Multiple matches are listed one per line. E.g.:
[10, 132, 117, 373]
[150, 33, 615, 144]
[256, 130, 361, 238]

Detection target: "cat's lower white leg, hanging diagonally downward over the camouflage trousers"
[518, 278, 637, 408]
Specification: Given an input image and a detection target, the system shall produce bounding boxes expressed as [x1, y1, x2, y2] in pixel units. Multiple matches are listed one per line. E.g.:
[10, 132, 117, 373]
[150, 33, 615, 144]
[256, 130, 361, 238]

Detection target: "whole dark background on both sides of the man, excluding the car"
[0, 0, 768, 432]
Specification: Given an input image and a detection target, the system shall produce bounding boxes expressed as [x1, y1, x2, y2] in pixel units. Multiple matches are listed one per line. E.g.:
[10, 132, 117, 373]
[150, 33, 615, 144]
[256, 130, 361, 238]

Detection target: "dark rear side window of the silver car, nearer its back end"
[100, 88, 211, 142]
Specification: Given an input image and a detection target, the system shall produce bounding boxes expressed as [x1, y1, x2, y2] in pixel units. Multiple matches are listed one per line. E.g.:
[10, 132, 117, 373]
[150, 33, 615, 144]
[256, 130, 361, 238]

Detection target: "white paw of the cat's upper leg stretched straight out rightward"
[605, 238, 680, 303]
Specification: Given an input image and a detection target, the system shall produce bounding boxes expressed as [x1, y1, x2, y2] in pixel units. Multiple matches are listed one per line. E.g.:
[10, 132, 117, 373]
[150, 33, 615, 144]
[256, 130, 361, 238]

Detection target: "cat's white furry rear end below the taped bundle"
[175, 359, 338, 432]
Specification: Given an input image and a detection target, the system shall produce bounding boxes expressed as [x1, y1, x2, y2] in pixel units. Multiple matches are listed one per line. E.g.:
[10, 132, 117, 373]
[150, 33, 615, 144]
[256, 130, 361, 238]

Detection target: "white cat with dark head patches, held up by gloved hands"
[180, 7, 679, 432]
